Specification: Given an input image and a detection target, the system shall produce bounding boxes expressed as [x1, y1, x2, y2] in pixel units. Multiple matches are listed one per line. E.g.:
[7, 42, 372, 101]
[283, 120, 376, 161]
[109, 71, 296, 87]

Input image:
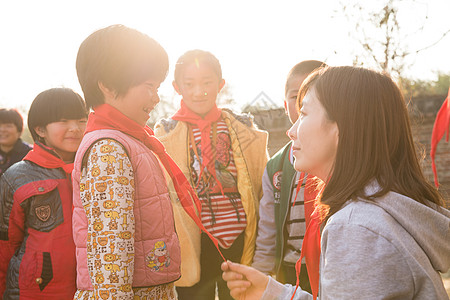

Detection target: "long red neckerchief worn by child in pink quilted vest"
[85, 104, 225, 261]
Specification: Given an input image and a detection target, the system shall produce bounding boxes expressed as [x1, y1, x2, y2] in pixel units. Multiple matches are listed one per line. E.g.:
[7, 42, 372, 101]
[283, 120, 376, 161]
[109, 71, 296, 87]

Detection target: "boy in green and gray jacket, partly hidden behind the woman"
[252, 60, 325, 291]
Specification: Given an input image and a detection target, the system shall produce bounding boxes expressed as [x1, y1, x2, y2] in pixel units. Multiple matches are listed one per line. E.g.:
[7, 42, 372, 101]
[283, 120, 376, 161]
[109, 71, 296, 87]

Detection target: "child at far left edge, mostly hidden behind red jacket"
[0, 108, 31, 176]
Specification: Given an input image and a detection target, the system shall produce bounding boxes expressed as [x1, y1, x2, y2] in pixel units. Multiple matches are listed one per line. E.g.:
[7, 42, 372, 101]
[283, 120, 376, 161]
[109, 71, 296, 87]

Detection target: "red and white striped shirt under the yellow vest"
[190, 119, 247, 249]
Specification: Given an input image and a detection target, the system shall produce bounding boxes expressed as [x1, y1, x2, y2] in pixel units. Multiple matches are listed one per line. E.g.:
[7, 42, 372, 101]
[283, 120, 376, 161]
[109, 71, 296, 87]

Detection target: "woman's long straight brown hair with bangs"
[298, 67, 444, 216]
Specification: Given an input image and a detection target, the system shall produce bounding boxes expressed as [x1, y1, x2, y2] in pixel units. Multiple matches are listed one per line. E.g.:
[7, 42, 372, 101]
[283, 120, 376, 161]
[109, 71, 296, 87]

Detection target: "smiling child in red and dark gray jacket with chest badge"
[0, 88, 87, 300]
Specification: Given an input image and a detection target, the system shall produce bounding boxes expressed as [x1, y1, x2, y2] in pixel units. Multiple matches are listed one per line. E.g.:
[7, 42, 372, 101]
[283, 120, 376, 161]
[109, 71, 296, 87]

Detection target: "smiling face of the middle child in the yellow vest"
[173, 62, 225, 117]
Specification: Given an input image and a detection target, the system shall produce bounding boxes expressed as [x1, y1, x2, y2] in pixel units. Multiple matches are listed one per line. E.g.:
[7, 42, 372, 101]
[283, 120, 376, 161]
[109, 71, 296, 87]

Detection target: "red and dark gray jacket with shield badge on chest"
[0, 146, 76, 300]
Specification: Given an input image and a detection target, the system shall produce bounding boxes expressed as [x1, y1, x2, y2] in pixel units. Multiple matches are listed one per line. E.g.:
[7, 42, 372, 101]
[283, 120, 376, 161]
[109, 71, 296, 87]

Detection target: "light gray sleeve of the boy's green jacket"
[252, 168, 277, 274]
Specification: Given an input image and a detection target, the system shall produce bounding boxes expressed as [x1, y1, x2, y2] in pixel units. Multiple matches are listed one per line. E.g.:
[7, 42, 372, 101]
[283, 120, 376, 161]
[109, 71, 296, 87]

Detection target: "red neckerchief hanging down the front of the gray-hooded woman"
[291, 172, 322, 300]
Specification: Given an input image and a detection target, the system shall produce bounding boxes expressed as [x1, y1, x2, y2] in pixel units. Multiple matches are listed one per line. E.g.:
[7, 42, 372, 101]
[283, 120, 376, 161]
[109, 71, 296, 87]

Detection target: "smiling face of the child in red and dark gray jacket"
[35, 118, 87, 162]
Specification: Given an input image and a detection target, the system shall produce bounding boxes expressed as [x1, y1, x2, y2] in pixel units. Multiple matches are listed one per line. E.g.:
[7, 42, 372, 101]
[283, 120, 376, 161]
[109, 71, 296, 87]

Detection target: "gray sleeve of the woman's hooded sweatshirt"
[319, 223, 414, 299]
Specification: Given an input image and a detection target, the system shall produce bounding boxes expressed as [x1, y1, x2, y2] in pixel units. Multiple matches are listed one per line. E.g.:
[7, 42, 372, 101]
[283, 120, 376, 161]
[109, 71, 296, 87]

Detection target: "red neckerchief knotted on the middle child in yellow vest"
[172, 100, 222, 190]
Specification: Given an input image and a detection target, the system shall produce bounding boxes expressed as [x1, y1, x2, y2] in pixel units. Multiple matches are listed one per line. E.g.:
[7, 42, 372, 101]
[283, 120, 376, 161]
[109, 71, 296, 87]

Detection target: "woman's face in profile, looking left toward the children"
[288, 88, 339, 182]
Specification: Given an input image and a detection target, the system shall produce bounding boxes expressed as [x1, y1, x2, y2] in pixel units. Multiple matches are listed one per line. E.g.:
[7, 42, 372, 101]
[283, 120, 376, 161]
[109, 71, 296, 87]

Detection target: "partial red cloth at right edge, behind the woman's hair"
[430, 88, 450, 187]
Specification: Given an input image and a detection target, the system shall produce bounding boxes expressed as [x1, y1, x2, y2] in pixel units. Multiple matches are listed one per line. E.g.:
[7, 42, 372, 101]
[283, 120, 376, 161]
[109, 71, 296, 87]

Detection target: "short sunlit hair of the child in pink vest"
[76, 25, 169, 109]
